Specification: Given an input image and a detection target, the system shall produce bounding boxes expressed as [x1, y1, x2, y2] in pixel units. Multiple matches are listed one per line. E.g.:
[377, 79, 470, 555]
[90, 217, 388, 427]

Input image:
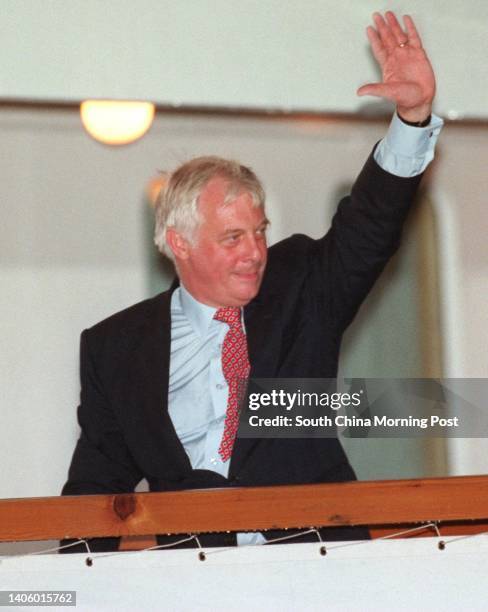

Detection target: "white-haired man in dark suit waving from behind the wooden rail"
[63, 13, 442, 549]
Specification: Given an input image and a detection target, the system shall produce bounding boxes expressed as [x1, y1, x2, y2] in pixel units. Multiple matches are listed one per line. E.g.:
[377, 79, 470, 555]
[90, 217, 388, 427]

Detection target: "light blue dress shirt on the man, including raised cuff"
[168, 114, 443, 545]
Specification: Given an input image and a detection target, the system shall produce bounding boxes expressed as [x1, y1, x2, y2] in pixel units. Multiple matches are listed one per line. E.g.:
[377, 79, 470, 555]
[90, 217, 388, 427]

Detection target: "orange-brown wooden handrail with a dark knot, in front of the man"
[0, 476, 488, 542]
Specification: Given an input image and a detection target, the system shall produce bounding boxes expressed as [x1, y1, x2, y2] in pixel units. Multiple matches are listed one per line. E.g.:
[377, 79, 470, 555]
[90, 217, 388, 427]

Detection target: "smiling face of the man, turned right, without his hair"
[177, 177, 268, 308]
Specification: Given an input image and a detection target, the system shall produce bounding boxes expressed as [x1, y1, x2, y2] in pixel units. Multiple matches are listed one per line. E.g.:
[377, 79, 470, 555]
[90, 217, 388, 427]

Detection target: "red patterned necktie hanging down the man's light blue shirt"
[214, 308, 250, 461]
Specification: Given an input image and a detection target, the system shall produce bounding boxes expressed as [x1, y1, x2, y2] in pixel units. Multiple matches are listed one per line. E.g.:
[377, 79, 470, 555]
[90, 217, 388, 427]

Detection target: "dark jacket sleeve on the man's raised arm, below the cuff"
[312, 146, 421, 330]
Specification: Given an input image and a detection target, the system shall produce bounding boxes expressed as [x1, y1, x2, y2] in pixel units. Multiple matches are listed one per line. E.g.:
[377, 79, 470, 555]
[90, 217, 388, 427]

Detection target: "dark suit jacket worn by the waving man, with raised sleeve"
[63, 156, 420, 544]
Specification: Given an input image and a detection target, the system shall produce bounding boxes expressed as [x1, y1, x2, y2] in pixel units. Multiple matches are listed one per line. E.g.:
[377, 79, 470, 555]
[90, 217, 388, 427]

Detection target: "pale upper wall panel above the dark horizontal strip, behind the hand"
[0, 0, 488, 117]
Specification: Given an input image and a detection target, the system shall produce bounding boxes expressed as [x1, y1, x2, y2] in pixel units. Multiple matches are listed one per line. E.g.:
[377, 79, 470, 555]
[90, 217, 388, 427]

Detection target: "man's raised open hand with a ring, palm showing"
[357, 11, 435, 122]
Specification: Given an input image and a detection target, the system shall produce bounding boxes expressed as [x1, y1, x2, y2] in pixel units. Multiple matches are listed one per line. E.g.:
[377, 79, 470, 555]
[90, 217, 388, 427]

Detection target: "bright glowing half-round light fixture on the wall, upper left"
[80, 100, 154, 145]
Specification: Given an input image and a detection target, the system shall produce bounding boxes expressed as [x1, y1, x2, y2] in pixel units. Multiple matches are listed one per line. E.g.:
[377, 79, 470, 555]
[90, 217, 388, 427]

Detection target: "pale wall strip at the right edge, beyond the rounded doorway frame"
[432, 126, 488, 475]
